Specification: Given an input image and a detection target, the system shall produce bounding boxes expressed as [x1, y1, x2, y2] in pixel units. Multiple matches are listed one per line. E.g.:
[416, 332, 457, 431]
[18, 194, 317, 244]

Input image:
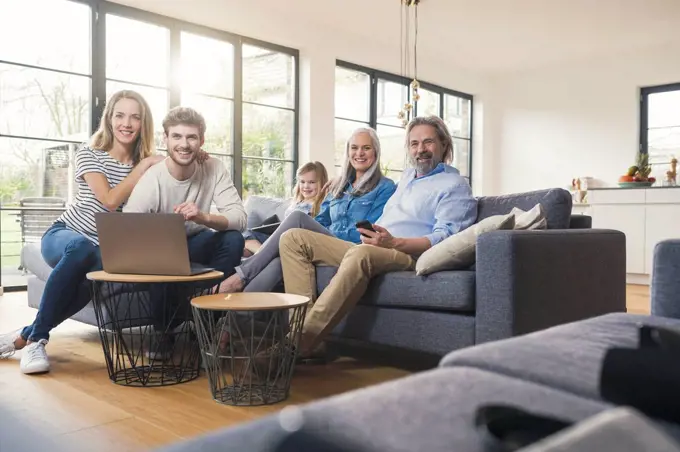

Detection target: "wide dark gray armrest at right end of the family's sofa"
[475, 229, 626, 343]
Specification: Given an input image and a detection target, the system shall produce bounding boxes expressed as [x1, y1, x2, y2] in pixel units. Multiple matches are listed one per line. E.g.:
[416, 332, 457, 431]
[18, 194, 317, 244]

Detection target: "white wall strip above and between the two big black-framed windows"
[113, 0, 488, 193]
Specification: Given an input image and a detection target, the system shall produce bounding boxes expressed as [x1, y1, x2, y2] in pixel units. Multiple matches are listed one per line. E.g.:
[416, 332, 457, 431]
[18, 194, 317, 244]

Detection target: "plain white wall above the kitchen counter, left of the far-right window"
[492, 43, 680, 194]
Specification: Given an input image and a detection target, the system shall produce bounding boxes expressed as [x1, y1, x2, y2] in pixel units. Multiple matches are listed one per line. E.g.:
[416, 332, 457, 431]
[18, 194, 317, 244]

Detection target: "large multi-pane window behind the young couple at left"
[0, 0, 299, 288]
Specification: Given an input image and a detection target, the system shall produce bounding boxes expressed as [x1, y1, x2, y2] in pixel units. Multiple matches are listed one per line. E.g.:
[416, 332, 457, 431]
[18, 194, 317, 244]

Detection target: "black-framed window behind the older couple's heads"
[335, 61, 472, 180]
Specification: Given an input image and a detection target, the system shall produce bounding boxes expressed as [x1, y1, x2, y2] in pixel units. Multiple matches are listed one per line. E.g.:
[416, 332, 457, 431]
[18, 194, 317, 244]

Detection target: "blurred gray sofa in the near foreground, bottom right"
[157, 313, 680, 452]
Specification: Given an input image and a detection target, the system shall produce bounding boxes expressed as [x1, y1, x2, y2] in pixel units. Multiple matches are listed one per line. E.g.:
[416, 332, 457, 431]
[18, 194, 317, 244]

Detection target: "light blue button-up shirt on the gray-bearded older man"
[376, 163, 477, 246]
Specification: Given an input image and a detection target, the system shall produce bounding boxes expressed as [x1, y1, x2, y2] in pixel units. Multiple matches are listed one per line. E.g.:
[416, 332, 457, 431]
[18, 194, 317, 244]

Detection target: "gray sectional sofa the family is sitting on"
[22, 189, 626, 368]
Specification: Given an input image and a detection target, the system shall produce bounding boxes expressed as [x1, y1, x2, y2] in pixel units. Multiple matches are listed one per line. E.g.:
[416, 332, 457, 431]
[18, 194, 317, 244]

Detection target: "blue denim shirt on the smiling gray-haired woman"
[315, 176, 397, 243]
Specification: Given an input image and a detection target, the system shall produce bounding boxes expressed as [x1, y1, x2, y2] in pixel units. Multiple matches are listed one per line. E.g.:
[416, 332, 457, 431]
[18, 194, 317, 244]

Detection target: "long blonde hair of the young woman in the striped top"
[90, 90, 156, 165]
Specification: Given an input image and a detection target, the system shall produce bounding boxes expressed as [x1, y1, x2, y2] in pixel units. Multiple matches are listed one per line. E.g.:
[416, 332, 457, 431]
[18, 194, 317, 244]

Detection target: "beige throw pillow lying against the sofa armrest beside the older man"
[416, 213, 515, 276]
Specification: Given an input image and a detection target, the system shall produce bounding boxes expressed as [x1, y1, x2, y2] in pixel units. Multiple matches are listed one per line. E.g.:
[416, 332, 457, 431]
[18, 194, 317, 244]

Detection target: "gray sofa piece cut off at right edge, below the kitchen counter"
[651, 239, 680, 319]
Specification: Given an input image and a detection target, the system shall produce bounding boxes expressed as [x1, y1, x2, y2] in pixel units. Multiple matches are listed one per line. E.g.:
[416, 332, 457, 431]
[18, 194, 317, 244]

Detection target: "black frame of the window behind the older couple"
[333, 59, 474, 186]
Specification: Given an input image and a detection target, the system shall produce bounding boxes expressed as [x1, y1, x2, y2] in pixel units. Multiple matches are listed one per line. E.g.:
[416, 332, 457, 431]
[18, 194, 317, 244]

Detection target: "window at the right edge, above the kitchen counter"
[640, 83, 680, 183]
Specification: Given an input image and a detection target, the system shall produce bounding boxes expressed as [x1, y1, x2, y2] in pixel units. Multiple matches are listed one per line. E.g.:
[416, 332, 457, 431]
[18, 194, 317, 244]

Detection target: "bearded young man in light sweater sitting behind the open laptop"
[123, 107, 247, 354]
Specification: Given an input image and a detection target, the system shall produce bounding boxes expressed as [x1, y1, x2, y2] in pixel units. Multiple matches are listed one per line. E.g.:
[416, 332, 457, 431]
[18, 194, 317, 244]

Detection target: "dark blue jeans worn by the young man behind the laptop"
[149, 230, 245, 331]
